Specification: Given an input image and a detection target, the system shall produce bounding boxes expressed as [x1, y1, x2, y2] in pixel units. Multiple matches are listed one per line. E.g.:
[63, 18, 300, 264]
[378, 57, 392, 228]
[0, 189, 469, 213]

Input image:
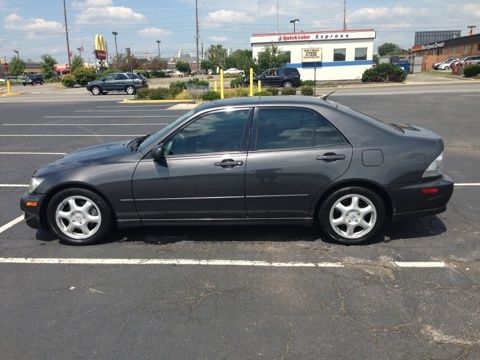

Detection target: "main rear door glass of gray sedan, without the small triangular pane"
[257, 109, 315, 150]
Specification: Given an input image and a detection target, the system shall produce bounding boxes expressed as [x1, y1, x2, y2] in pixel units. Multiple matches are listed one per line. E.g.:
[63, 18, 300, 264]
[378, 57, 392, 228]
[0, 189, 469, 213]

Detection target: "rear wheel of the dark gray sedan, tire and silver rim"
[318, 186, 386, 245]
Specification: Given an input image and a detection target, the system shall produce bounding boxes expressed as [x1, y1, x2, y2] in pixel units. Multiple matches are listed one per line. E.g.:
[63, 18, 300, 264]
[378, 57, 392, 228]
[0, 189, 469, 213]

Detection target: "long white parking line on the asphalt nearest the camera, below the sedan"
[0, 257, 448, 269]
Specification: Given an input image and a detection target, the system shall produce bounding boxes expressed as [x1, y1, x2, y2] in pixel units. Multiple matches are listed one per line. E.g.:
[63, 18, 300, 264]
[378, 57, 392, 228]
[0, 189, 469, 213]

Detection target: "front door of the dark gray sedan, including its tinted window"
[133, 109, 251, 224]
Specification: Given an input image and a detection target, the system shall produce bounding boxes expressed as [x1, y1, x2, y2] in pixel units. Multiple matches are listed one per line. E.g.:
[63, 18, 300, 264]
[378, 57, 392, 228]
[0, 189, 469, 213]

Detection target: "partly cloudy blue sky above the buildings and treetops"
[0, 0, 480, 63]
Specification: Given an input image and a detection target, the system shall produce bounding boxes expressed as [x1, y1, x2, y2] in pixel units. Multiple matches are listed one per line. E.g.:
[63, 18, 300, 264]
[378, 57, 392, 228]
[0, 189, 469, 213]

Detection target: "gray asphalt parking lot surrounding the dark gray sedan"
[0, 84, 480, 360]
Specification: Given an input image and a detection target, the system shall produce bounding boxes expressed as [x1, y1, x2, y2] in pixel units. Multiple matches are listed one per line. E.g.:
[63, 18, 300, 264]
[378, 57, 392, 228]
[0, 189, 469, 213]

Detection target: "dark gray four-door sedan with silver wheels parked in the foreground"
[21, 97, 453, 244]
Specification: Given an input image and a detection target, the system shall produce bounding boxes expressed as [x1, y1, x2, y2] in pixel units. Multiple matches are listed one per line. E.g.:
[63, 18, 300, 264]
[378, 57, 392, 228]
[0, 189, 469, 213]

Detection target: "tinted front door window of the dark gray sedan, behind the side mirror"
[165, 110, 249, 155]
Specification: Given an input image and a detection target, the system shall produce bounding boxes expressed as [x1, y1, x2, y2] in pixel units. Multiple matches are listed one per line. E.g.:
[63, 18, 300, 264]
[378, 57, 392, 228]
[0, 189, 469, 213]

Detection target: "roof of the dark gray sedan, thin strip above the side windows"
[197, 95, 337, 111]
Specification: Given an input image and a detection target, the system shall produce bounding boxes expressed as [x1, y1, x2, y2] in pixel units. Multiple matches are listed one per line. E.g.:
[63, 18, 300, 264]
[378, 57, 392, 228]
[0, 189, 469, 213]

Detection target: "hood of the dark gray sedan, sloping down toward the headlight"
[35, 140, 137, 177]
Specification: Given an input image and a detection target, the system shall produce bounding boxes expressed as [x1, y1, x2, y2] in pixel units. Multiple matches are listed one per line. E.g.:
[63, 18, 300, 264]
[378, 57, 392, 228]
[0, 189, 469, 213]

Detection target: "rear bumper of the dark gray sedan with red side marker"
[388, 175, 454, 221]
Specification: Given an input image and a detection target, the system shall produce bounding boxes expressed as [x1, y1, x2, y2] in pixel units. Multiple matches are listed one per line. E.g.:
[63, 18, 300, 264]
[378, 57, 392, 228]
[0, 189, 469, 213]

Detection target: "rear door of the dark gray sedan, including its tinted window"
[245, 107, 352, 219]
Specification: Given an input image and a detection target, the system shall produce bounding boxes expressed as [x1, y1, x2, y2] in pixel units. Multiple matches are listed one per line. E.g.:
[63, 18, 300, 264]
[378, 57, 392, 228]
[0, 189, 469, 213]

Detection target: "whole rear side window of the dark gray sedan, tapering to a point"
[256, 109, 345, 150]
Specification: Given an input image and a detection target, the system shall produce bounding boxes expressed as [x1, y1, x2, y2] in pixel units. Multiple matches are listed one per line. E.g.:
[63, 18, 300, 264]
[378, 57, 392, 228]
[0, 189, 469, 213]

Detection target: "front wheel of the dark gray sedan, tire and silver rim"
[47, 188, 112, 245]
